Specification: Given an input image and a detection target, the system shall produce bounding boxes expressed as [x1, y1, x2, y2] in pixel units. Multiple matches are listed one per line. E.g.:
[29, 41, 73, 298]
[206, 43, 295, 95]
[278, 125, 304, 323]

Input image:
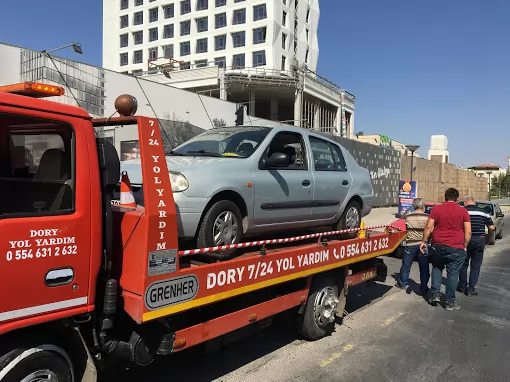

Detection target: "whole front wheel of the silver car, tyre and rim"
[197, 200, 243, 255]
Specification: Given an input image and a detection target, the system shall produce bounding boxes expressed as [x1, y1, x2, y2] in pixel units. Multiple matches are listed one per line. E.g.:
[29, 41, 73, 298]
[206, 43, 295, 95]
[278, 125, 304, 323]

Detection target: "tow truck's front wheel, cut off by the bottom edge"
[0, 345, 73, 382]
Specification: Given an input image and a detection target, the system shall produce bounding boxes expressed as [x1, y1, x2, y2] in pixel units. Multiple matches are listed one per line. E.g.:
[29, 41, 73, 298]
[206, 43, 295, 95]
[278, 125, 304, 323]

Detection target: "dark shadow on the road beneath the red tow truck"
[99, 283, 392, 382]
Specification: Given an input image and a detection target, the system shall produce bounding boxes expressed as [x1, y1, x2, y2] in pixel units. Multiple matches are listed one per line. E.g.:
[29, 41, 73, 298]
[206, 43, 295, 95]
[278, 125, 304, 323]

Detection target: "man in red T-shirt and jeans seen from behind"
[420, 188, 471, 310]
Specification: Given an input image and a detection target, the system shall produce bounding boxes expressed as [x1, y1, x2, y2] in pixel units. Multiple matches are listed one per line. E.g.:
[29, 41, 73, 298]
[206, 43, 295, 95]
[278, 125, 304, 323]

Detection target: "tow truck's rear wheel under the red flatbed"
[298, 275, 343, 341]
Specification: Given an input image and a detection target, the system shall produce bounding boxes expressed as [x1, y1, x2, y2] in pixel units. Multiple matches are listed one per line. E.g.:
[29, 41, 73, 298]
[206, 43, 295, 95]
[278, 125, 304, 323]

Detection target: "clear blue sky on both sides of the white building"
[0, 0, 510, 166]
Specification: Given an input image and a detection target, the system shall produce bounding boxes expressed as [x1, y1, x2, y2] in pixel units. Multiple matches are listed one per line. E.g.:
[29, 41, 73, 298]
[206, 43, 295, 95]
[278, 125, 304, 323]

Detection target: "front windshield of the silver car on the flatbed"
[170, 126, 271, 158]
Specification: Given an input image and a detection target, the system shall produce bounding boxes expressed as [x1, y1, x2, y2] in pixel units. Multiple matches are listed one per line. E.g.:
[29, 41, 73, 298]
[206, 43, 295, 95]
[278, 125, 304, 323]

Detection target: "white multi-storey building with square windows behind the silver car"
[103, 0, 354, 137]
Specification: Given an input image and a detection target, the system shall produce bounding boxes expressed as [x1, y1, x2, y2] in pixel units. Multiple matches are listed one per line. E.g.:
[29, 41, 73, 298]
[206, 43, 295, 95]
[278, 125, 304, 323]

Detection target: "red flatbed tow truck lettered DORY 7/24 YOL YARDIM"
[0, 82, 405, 382]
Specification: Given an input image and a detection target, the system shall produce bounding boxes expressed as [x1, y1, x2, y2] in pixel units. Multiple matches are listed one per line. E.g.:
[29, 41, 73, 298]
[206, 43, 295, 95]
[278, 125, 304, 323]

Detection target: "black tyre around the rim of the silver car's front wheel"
[197, 200, 243, 255]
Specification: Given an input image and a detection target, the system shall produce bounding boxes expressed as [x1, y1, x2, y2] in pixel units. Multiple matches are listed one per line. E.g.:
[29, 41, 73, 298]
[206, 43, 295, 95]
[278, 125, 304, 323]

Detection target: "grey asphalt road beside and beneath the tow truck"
[104, 217, 510, 382]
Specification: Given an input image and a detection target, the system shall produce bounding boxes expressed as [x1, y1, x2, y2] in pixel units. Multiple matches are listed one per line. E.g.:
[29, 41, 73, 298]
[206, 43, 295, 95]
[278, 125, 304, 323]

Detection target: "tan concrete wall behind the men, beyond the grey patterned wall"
[400, 157, 488, 202]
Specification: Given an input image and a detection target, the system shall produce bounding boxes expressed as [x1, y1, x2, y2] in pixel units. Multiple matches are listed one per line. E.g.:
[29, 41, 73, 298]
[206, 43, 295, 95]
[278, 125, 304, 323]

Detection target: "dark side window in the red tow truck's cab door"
[0, 112, 75, 217]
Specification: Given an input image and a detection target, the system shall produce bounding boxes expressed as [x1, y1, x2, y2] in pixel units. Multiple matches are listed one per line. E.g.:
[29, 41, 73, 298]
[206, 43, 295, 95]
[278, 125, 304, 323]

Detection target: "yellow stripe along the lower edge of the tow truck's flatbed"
[142, 241, 400, 322]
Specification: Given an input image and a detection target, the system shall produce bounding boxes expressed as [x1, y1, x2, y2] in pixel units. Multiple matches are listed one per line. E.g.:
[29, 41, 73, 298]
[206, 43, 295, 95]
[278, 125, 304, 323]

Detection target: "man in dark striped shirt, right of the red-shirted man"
[457, 196, 494, 296]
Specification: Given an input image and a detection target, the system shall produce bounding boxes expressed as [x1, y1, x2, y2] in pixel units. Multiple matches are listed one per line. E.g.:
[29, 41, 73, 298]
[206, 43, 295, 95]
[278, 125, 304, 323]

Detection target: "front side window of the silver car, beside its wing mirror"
[262, 131, 308, 170]
